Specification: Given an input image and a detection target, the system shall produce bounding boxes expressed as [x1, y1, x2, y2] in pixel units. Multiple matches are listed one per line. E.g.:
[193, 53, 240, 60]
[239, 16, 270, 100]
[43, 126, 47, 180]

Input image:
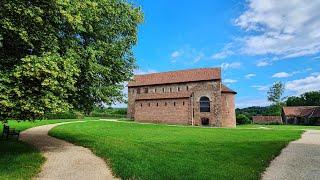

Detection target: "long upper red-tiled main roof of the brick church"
[128, 68, 221, 87]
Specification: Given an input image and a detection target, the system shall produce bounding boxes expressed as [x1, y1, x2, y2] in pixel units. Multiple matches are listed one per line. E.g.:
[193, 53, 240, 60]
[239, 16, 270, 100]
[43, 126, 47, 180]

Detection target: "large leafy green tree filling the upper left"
[0, 0, 143, 119]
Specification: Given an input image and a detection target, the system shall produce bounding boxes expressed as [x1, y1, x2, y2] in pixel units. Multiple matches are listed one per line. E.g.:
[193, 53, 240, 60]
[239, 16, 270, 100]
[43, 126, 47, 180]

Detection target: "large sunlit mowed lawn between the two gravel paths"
[50, 121, 303, 179]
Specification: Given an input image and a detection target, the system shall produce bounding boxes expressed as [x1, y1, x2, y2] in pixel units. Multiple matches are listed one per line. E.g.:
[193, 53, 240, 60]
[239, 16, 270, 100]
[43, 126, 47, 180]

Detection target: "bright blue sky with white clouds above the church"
[129, 0, 320, 107]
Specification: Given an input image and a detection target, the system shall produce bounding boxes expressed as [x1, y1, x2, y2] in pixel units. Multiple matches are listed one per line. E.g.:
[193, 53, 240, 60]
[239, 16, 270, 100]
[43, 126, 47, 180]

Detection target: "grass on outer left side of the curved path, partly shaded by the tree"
[0, 119, 94, 179]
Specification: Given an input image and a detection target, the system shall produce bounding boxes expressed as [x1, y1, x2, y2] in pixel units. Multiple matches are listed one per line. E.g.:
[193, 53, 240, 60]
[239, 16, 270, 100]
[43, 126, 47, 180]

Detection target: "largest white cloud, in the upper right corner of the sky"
[235, 0, 320, 58]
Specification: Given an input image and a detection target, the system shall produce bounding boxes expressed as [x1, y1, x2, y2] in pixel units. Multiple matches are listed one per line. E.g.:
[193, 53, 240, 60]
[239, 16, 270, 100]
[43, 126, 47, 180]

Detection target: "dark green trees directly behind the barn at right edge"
[286, 91, 320, 106]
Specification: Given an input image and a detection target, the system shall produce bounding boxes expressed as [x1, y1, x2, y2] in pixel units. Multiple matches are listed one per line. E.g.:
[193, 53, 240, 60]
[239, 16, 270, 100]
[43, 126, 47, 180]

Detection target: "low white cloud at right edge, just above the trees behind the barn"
[285, 75, 320, 94]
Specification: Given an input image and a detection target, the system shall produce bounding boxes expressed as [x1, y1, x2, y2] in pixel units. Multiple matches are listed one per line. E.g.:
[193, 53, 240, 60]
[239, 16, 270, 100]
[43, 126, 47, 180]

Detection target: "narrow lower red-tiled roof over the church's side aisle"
[136, 91, 191, 100]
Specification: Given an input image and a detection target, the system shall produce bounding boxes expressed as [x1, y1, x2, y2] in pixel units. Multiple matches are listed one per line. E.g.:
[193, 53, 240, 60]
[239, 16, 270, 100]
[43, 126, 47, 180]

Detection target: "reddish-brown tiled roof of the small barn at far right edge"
[283, 106, 320, 117]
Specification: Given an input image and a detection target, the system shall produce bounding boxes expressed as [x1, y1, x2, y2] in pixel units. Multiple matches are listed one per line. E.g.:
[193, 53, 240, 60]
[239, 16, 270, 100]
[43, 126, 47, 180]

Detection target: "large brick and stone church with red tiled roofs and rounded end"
[127, 68, 236, 127]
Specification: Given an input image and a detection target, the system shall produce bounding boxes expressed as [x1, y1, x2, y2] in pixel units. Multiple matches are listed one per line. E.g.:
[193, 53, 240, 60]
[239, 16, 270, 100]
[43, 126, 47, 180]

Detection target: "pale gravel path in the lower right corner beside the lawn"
[262, 130, 320, 180]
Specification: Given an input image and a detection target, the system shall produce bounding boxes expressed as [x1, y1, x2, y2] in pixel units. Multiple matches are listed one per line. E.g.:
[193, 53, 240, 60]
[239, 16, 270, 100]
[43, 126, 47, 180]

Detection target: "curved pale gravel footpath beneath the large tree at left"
[20, 121, 115, 180]
